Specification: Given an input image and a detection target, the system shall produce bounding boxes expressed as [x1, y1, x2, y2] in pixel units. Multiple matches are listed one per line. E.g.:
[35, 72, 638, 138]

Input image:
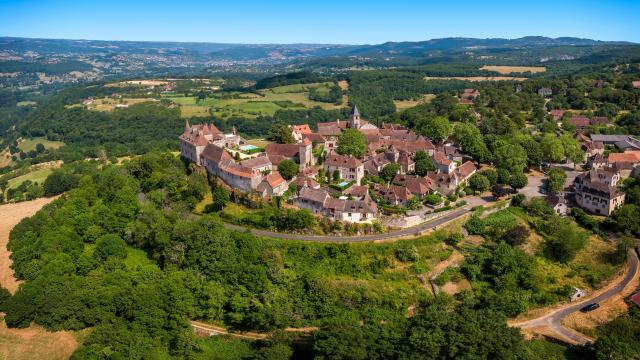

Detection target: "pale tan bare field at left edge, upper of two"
[0, 198, 55, 294]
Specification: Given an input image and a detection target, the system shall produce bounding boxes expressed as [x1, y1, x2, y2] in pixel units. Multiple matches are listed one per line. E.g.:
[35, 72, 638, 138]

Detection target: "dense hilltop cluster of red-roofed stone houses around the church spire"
[180, 106, 476, 223]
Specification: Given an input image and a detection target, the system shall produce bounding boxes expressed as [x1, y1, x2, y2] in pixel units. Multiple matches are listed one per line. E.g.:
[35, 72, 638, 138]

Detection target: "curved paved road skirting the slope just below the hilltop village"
[224, 206, 471, 242]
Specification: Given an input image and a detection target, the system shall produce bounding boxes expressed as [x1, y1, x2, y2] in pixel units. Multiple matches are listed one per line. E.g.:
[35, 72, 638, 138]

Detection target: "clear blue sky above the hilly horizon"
[0, 0, 640, 44]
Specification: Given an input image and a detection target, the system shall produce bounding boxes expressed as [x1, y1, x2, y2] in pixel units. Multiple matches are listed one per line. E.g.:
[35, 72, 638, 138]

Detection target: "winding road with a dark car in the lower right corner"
[513, 250, 639, 344]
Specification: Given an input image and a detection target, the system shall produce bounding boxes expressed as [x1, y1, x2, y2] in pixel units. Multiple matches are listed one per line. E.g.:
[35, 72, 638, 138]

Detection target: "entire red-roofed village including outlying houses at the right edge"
[180, 98, 640, 227]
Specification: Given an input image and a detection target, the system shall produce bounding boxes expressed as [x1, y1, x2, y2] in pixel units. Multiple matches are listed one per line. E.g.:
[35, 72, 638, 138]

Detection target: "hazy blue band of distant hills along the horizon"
[0, 36, 633, 60]
